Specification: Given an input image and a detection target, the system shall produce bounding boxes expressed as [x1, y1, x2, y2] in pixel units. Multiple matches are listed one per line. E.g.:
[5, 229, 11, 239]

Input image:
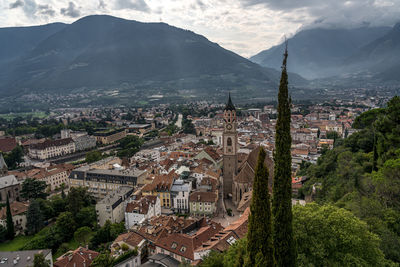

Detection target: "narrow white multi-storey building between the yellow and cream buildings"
[171, 179, 192, 213]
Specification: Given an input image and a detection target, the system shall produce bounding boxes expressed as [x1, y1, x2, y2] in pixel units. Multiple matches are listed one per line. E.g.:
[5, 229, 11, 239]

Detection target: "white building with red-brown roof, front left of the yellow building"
[125, 195, 161, 229]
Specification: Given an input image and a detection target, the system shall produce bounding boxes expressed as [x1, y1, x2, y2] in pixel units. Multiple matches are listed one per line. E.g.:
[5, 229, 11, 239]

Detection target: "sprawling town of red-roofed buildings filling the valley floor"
[0, 90, 389, 267]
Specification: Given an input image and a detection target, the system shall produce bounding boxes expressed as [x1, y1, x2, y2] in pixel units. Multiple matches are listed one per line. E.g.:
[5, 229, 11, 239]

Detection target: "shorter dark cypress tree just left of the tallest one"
[246, 148, 275, 267]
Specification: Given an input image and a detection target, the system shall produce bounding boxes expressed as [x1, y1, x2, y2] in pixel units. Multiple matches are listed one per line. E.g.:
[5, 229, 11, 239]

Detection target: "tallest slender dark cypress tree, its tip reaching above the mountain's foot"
[272, 44, 296, 267]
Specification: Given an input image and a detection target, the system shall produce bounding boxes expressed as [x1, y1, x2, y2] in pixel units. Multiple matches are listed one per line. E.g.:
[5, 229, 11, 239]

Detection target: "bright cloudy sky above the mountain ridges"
[0, 0, 400, 57]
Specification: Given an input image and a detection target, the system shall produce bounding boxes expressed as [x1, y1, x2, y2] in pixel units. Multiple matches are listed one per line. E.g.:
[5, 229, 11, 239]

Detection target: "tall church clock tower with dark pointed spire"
[223, 94, 238, 198]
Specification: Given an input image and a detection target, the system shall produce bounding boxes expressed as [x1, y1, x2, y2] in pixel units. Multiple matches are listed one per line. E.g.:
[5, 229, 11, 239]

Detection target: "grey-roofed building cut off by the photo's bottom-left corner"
[0, 249, 52, 267]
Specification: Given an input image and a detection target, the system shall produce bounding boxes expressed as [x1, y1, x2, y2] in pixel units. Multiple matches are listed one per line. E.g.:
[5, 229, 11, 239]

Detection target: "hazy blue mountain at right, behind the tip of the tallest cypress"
[250, 27, 390, 79]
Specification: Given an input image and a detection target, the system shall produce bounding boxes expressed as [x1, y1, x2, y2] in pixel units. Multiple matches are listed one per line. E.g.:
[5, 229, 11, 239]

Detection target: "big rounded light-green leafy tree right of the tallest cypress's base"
[293, 203, 387, 266]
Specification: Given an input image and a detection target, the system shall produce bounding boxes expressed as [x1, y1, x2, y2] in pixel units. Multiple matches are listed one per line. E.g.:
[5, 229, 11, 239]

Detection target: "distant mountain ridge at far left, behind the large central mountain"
[0, 23, 65, 68]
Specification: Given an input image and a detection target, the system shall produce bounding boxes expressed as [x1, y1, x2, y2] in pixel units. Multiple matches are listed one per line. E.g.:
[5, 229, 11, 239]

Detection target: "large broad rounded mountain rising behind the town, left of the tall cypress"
[0, 15, 305, 99]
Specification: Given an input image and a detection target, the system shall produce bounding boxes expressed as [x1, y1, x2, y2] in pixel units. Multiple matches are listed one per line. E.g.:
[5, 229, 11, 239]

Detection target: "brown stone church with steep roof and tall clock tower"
[222, 94, 274, 206]
